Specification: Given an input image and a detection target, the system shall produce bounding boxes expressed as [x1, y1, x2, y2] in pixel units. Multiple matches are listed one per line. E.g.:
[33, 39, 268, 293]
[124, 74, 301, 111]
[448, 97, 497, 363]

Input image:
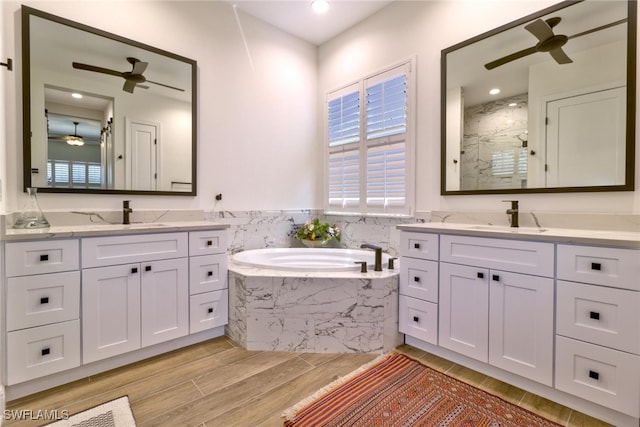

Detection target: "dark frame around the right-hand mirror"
[440, 0, 637, 196]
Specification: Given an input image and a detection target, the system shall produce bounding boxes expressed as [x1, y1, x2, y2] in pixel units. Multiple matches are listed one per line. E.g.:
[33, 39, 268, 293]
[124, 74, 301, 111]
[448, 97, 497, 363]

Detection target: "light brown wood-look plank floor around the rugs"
[4, 337, 609, 427]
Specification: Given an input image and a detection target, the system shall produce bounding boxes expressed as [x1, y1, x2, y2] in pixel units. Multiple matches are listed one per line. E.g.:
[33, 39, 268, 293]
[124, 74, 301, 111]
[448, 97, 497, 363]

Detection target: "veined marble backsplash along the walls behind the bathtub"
[205, 209, 429, 255]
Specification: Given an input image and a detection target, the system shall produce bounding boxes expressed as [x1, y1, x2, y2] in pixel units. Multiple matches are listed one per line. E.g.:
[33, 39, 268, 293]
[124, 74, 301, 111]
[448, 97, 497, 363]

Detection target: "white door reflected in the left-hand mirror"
[129, 122, 158, 191]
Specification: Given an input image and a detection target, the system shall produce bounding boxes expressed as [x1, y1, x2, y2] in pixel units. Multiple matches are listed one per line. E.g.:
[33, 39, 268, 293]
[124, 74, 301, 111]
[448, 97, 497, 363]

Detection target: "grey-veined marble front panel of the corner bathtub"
[225, 262, 403, 353]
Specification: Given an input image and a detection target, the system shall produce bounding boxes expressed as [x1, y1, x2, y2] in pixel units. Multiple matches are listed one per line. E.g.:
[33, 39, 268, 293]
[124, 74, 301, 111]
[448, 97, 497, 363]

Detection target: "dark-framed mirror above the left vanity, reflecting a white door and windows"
[22, 6, 197, 196]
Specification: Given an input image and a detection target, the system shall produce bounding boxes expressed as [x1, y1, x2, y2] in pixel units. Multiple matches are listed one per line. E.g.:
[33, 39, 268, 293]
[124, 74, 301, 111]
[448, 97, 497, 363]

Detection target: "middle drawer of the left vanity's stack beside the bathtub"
[189, 254, 227, 295]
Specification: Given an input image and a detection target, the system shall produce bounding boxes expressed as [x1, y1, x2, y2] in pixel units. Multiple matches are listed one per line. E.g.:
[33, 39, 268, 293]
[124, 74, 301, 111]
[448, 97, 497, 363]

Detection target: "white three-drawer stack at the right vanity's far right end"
[556, 245, 640, 418]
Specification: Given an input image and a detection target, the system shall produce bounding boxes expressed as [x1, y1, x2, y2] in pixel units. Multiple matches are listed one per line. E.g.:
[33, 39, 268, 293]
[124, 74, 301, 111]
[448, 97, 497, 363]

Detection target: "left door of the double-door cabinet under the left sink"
[82, 264, 140, 363]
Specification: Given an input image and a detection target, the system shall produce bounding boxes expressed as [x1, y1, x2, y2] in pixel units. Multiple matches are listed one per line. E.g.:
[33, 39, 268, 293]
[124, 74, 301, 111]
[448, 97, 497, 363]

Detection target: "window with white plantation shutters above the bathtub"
[325, 61, 414, 215]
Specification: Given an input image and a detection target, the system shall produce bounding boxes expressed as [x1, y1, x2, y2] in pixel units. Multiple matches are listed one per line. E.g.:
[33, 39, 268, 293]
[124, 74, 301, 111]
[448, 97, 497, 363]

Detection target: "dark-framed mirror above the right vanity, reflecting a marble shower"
[441, 0, 637, 195]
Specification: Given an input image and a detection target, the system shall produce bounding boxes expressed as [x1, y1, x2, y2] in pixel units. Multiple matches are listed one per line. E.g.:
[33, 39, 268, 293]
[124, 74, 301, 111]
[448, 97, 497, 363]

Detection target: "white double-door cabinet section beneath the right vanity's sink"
[438, 235, 555, 385]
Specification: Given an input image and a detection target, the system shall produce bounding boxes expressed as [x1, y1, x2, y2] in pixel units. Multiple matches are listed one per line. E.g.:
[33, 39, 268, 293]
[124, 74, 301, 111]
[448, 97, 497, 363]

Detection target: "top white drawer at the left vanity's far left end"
[6, 239, 80, 277]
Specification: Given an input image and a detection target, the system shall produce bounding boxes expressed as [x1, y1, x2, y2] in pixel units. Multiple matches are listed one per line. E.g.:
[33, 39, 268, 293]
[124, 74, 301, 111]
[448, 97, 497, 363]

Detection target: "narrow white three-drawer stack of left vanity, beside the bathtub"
[189, 230, 229, 333]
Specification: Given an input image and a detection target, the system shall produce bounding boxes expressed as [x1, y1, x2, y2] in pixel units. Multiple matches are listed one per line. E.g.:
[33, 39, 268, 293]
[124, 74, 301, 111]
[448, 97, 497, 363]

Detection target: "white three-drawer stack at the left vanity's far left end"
[3, 239, 80, 385]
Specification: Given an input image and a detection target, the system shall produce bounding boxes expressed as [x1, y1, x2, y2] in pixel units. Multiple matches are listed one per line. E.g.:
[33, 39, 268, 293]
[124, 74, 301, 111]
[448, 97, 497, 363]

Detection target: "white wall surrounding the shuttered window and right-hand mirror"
[318, 0, 640, 214]
